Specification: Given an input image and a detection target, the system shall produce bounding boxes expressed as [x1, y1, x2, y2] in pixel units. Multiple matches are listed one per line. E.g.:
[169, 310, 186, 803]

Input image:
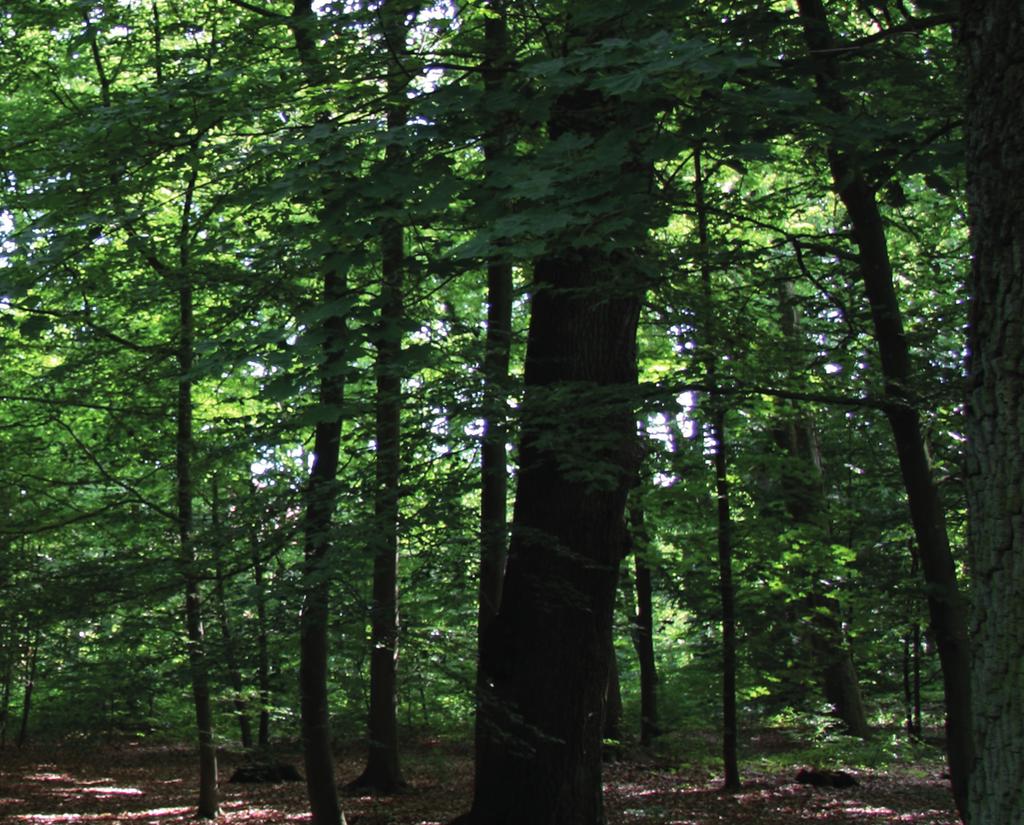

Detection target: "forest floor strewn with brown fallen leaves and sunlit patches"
[0, 741, 958, 825]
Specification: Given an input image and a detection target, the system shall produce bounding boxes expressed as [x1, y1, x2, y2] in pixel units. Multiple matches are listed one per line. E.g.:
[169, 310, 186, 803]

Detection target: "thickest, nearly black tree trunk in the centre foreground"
[461, 90, 647, 825]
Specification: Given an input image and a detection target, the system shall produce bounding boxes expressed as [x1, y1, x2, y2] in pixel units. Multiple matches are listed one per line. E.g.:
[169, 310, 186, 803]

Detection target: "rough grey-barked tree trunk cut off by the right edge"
[963, 0, 1024, 825]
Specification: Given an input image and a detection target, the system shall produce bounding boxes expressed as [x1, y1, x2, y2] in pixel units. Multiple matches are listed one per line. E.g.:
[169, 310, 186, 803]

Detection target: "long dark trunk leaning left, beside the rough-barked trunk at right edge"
[798, 0, 974, 818]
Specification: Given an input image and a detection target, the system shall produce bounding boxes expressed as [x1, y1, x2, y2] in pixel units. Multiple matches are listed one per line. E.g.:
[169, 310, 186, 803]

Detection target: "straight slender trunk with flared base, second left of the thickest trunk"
[350, 0, 418, 794]
